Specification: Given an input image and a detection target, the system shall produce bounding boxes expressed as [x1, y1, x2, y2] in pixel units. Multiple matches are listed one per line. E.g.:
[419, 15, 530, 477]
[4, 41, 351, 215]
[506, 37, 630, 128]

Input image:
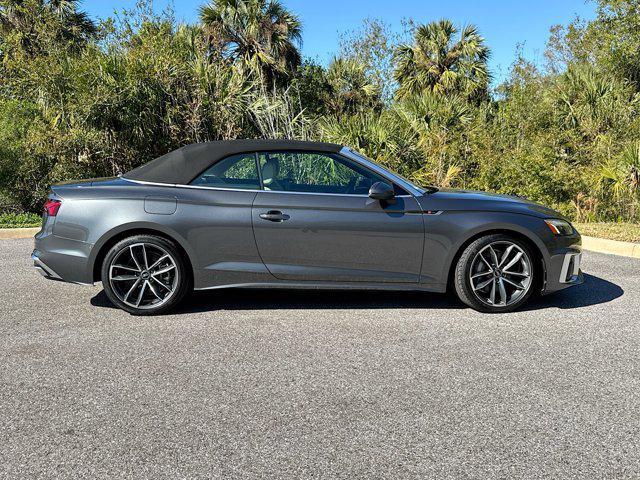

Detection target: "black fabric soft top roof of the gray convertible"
[122, 140, 342, 185]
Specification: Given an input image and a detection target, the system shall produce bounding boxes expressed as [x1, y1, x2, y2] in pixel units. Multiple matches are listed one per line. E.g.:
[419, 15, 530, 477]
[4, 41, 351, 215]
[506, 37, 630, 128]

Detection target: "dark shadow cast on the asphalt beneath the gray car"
[91, 275, 624, 314]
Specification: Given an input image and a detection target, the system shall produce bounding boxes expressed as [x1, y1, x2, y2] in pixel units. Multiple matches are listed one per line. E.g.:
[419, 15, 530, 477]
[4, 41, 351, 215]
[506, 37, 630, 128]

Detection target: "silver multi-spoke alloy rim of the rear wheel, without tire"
[109, 243, 180, 309]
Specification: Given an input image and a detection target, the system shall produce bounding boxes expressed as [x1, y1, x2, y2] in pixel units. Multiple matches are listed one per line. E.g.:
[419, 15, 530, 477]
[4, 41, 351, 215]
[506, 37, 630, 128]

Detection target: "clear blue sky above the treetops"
[81, 0, 595, 82]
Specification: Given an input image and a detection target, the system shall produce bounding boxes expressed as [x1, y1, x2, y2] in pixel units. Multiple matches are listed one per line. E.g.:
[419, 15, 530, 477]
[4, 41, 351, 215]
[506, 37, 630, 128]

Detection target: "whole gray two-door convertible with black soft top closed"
[32, 140, 583, 315]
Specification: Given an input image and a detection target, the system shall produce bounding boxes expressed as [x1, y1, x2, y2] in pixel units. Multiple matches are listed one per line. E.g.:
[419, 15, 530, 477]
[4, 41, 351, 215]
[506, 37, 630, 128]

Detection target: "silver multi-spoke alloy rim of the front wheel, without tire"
[469, 240, 532, 307]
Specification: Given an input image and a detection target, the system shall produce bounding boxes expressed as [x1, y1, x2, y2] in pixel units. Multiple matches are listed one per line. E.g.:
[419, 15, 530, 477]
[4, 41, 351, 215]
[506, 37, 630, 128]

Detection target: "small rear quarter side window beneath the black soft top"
[191, 153, 260, 190]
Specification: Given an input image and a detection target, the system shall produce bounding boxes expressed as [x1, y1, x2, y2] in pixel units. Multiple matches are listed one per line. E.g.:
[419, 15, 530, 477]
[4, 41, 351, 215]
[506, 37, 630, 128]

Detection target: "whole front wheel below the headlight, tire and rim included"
[454, 234, 538, 313]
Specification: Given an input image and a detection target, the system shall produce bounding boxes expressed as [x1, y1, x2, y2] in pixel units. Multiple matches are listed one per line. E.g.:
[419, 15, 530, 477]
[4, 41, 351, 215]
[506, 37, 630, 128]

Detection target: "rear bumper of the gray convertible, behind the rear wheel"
[31, 231, 93, 284]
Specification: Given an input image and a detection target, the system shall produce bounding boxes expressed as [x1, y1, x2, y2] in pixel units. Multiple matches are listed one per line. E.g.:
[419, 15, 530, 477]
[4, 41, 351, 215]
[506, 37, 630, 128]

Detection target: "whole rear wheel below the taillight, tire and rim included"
[102, 235, 191, 315]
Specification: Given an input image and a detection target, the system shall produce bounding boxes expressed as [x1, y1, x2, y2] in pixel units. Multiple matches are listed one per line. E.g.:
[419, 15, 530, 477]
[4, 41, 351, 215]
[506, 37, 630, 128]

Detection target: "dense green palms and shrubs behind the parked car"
[0, 0, 640, 221]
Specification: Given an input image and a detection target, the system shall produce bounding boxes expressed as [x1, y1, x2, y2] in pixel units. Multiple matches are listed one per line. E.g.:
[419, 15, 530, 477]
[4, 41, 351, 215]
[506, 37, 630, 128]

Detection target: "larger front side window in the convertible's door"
[258, 152, 386, 195]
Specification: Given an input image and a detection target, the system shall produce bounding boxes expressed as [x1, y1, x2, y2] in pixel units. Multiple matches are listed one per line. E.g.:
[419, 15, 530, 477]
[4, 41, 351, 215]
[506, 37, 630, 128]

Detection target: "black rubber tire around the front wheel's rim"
[453, 234, 539, 313]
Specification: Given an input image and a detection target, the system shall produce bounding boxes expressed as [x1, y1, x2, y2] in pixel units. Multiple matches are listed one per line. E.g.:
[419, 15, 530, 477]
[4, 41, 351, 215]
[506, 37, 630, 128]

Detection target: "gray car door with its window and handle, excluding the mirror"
[252, 152, 424, 283]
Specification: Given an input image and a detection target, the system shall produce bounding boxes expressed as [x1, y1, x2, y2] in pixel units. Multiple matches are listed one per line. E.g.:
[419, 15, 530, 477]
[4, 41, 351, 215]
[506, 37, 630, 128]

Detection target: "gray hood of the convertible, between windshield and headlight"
[419, 188, 565, 219]
